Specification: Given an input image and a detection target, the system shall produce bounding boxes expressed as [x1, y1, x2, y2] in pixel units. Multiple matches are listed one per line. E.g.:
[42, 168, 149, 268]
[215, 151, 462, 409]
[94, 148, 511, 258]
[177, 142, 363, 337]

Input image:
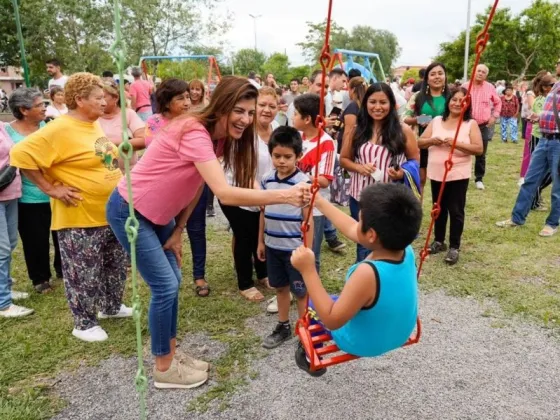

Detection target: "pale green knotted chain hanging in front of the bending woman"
[110, 0, 148, 419]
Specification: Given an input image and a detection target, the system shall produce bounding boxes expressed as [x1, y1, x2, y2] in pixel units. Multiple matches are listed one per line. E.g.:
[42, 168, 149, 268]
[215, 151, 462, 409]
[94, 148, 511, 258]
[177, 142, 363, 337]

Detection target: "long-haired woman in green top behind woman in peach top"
[403, 62, 448, 196]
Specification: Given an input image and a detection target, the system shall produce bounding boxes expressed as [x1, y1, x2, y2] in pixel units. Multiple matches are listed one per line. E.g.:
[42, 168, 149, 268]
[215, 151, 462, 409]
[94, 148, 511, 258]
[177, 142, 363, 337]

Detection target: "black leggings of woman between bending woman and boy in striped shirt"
[220, 203, 268, 290]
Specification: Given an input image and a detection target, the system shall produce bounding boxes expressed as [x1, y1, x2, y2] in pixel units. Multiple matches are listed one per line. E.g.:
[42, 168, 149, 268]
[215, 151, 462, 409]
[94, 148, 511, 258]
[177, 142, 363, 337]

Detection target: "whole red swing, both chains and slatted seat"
[296, 0, 499, 371]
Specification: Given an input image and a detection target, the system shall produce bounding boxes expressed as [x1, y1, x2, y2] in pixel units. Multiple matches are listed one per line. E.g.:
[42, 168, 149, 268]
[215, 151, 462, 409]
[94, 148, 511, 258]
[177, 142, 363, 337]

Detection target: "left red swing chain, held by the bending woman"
[301, 0, 333, 246]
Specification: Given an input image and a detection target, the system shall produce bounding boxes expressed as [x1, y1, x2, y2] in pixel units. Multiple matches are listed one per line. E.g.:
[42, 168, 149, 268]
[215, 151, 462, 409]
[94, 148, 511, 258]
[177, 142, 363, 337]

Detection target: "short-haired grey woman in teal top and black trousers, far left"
[6, 88, 62, 293]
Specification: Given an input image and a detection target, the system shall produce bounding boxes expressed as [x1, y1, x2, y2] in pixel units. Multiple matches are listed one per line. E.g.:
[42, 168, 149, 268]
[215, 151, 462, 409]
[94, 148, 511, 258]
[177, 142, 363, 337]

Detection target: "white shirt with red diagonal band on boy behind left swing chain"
[298, 131, 336, 216]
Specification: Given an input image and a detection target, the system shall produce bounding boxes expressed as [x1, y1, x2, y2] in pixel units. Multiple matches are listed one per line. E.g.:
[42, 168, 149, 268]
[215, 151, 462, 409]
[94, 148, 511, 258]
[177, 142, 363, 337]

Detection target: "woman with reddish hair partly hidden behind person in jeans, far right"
[529, 73, 556, 211]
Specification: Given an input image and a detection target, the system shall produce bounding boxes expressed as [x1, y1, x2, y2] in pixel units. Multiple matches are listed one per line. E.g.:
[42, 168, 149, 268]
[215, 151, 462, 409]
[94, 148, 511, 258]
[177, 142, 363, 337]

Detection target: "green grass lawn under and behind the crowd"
[0, 140, 560, 420]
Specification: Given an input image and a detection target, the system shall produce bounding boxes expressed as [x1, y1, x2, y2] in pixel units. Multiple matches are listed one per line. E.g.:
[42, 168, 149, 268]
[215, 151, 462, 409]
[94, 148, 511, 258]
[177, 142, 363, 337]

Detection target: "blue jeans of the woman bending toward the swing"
[107, 190, 181, 356]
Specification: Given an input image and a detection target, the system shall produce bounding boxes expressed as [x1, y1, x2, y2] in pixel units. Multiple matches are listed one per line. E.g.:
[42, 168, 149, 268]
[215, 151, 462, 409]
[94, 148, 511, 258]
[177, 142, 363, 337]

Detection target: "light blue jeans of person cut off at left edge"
[0, 198, 18, 309]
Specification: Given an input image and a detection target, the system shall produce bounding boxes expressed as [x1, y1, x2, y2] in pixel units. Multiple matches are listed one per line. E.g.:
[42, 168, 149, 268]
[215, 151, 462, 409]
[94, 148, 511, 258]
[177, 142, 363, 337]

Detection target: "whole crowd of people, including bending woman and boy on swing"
[0, 55, 560, 388]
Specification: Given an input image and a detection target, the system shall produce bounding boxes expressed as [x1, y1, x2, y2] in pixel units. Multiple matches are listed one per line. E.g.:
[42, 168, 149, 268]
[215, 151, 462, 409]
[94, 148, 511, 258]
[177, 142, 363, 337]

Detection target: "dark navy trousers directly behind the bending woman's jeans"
[187, 185, 208, 280]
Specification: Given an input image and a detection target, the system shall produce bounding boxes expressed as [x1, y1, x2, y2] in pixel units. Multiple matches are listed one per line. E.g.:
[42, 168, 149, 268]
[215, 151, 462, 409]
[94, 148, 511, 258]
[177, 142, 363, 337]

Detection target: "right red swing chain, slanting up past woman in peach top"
[417, 0, 500, 279]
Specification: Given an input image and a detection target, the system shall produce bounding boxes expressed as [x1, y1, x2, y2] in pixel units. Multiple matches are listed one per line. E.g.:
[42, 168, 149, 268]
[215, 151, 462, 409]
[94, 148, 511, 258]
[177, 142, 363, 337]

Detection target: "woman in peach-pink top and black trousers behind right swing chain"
[418, 88, 483, 265]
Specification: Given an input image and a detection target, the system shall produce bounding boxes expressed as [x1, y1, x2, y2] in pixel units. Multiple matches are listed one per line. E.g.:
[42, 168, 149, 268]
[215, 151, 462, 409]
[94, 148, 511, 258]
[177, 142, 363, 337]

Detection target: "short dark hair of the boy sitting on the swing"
[359, 184, 422, 251]
